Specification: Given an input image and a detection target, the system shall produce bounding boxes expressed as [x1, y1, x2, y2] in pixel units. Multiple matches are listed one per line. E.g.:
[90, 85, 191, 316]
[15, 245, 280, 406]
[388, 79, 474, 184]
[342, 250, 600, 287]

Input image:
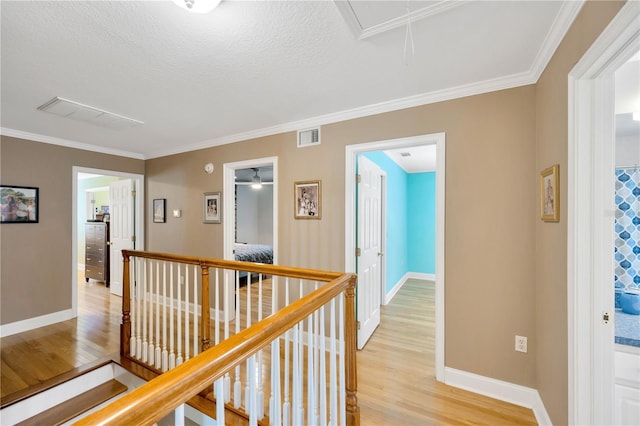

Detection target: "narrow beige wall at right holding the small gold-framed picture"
[534, 1, 624, 424]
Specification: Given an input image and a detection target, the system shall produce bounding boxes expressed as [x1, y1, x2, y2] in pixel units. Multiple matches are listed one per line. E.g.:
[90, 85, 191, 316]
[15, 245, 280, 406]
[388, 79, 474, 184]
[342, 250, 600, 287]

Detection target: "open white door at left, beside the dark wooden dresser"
[109, 179, 134, 296]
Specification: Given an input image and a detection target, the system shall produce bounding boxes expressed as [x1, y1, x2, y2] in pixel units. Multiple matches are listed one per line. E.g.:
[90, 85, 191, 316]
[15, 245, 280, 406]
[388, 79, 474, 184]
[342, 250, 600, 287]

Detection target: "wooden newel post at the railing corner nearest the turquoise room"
[344, 275, 360, 426]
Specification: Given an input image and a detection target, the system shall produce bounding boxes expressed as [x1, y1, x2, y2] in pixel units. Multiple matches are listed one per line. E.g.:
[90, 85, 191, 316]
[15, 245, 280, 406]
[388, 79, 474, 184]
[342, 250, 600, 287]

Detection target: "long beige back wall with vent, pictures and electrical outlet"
[146, 86, 537, 387]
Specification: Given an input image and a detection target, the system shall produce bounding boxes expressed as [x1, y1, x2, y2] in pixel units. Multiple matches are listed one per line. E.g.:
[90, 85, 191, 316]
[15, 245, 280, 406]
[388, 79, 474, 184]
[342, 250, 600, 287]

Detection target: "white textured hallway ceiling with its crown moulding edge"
[0, 0, 582, 158]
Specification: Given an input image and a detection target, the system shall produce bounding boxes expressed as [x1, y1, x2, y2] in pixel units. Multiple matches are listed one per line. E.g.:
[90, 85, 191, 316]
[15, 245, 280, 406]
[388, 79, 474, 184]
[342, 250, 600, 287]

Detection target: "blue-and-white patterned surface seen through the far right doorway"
[615, 167, 640, 290]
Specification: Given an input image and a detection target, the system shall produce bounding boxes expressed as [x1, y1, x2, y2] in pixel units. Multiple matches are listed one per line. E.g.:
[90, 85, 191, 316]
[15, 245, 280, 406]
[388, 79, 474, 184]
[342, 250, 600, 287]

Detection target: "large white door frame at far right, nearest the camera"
[567, 2, 640, 424]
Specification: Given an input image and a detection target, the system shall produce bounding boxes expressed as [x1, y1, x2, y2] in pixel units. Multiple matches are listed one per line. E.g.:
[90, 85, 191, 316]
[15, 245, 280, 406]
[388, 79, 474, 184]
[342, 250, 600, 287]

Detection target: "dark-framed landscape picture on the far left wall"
[0, 185, 40, 223]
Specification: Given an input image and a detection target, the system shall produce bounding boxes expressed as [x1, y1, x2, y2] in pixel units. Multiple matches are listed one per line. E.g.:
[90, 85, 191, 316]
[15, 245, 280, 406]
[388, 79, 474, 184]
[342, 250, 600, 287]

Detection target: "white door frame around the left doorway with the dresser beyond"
[71, 166, 145, 318]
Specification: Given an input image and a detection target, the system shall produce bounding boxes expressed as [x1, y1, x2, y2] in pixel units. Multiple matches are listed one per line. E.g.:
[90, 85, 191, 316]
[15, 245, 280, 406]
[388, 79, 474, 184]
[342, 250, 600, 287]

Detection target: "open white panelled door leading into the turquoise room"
[356, 155, 382, 349]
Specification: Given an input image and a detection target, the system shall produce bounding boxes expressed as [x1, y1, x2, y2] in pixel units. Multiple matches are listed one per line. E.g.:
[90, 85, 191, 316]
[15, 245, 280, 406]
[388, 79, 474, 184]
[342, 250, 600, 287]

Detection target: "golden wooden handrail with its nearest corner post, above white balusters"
[75, 260, 360, 426]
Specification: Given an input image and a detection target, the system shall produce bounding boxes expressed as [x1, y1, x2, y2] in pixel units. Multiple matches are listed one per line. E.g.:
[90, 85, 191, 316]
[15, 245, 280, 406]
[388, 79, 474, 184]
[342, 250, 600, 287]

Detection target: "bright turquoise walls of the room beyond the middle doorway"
[363, 152, 436, 292]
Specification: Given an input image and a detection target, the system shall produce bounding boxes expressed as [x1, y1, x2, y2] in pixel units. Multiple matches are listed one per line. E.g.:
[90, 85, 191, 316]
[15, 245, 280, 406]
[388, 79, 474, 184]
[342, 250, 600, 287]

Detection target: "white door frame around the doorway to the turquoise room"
[344, 133, 446, 381]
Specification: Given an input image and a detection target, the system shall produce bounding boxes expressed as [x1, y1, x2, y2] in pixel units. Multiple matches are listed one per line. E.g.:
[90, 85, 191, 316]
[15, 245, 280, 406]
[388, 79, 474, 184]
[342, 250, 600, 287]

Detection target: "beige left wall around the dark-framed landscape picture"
[0, 136, 144, 325]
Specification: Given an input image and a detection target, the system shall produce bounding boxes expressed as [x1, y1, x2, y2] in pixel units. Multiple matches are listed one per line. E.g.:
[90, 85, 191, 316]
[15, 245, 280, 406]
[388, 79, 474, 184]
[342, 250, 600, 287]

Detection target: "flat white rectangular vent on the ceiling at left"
[38, 97, 144, 130]
